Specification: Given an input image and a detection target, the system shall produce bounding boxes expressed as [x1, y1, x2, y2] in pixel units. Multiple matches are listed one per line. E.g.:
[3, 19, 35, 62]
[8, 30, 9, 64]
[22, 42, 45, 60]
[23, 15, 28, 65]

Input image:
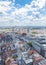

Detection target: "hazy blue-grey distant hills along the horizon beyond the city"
[0, 26, 46, 29]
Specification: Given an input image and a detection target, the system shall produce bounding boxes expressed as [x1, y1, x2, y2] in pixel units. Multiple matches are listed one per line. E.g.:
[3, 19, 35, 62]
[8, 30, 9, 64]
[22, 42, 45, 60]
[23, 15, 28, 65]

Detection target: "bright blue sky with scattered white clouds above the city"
[0, 0, 46, 27]
